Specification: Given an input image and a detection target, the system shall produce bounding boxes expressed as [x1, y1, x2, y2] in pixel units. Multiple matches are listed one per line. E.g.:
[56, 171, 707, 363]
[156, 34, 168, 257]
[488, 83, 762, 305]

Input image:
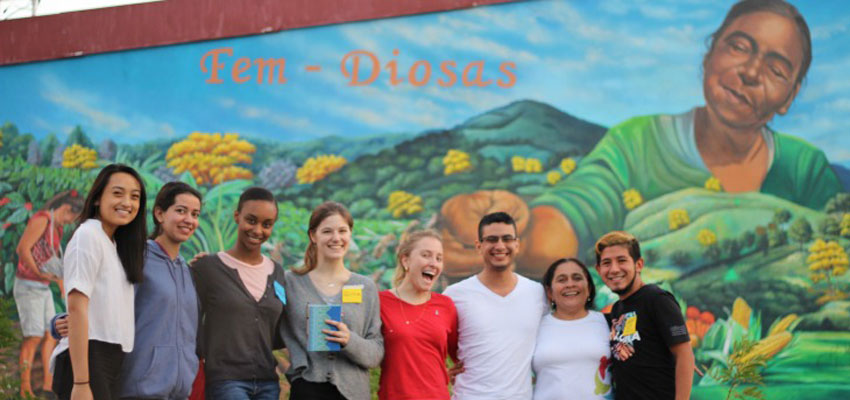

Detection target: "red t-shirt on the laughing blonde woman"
[378, 290, 457, 400]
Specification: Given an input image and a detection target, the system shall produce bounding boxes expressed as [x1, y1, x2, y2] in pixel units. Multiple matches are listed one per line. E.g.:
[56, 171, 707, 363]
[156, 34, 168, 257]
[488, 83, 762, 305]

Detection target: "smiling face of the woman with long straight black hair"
[96, 172, 142, 236]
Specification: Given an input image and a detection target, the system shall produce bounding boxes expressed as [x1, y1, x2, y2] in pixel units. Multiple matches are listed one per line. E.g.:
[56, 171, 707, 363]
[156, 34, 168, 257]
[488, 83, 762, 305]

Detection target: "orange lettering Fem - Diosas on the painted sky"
[201, 47, 516, 88]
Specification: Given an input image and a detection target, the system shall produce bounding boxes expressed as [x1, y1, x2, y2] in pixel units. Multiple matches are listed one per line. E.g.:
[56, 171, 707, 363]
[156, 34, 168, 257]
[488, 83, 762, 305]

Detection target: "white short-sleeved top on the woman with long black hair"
[63, 218, 136, 353]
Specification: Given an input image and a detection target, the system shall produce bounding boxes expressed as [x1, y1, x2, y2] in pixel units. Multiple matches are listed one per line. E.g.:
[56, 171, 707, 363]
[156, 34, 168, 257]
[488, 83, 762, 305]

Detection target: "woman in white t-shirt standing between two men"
[531, 258, 614, 400]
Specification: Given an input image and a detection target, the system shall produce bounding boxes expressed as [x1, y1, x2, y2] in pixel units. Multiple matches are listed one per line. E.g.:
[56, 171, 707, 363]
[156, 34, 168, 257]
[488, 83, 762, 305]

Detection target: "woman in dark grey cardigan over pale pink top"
[189, 187, 285, 400]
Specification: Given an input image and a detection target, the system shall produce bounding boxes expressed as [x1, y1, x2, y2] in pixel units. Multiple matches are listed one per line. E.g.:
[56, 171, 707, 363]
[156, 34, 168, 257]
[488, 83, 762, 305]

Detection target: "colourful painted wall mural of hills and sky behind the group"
[0, 0, 850, 399]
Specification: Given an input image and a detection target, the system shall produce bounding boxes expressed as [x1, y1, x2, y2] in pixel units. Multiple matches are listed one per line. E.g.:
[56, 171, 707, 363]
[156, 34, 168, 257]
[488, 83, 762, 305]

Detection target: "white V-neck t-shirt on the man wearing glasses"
[443, 274, 548, 400]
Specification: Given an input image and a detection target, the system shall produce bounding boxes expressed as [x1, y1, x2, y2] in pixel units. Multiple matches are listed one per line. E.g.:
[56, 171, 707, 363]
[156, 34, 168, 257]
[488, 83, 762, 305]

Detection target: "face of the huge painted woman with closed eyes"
[703, 12, 803, 129]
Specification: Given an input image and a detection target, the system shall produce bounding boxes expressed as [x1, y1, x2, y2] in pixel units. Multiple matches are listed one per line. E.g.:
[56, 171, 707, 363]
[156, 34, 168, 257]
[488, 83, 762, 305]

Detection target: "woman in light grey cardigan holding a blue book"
[283, 201, 384, 400]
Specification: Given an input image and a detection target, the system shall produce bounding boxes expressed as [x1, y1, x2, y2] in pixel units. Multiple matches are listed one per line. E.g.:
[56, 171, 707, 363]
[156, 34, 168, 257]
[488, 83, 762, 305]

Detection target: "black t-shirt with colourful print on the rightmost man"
[610, 285, 690, 400]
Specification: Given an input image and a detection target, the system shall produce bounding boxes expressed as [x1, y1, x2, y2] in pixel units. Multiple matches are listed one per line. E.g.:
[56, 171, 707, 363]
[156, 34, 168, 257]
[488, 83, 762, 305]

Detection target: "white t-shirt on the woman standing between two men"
[532, 311, 611, 400]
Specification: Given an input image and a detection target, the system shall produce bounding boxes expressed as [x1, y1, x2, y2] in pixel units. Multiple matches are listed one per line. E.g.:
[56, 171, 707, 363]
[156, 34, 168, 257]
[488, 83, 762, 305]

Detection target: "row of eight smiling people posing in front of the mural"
[16, 164, 693, 400]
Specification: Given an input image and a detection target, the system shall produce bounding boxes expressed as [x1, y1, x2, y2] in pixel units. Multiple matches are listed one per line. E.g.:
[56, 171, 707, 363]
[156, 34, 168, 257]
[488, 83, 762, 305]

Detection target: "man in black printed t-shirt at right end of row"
[596, 231, 694, 400]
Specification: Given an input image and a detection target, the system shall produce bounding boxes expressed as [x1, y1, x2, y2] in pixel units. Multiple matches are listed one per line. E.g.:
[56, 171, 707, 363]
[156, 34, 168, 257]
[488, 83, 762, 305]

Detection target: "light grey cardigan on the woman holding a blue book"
[281, 271, 384, 400]
